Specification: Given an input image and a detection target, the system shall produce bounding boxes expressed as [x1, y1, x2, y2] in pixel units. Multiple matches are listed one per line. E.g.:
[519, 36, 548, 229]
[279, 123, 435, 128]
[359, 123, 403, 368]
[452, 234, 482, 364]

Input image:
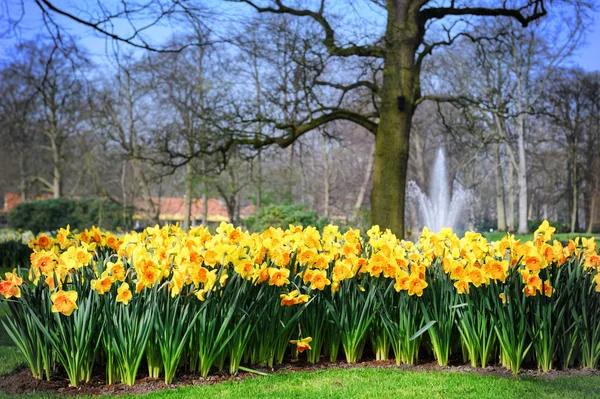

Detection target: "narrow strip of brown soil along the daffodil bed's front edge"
[0, 361, 600, 396]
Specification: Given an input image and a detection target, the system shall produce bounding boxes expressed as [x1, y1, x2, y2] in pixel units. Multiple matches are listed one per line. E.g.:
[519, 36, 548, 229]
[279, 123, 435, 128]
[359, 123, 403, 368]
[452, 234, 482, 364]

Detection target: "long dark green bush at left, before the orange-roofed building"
[8, 198, 131, 234]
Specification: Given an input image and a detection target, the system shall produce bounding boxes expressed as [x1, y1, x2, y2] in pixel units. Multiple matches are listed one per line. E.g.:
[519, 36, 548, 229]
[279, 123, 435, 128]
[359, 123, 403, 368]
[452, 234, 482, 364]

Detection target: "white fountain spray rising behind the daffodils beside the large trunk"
[408, 148, 471, 232]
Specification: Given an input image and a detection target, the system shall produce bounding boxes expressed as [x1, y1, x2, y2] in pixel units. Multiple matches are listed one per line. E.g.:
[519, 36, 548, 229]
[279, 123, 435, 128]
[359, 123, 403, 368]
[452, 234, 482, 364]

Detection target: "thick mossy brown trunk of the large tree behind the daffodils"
[371, 0, 420, 237]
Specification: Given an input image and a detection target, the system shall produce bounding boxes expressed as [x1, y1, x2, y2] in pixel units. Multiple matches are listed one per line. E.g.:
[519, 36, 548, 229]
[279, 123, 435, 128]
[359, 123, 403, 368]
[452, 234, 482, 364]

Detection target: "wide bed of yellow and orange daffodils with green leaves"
[0, 222, 600, 386]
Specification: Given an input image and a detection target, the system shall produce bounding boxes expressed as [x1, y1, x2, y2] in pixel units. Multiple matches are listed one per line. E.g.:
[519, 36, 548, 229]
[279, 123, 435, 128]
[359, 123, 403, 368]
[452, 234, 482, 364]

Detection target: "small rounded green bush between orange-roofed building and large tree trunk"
[246, 202, 328, 231]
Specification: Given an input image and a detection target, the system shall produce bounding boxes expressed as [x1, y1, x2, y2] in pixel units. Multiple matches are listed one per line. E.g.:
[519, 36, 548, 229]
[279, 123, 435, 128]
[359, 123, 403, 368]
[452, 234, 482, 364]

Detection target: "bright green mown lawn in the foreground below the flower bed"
[3, 368, 600, 399]
